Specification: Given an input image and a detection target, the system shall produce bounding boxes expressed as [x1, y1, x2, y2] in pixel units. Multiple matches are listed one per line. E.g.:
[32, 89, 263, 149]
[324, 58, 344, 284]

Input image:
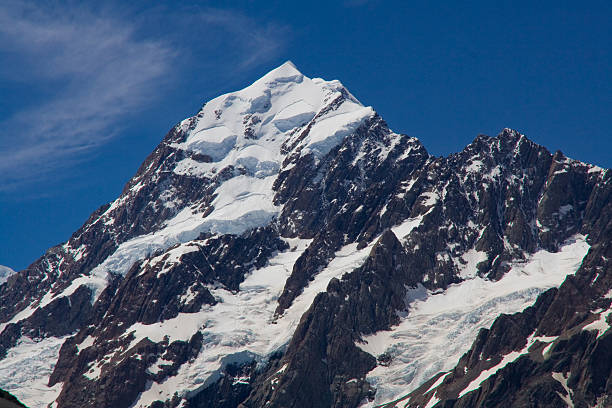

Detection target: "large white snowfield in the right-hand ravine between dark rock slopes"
[357, 235, 589, 407]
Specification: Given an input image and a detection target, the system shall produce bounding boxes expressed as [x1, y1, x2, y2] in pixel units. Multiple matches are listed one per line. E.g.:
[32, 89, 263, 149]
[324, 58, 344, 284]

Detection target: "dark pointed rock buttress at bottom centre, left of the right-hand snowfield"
[243, 230, 417, 407]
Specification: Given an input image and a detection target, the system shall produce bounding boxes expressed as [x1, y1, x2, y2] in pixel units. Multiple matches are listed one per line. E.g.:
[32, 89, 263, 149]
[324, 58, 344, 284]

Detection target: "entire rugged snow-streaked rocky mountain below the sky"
[0, 62, 612, 408]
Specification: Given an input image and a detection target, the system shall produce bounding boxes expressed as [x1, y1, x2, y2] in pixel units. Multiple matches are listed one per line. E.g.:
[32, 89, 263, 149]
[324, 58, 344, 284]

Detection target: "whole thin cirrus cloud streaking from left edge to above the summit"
[0, 1, 284, 191]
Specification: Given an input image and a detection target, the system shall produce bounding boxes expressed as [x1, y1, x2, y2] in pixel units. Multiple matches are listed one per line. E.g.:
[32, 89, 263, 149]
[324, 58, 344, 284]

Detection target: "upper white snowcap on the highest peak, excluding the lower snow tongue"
[175, 62, 373, 170]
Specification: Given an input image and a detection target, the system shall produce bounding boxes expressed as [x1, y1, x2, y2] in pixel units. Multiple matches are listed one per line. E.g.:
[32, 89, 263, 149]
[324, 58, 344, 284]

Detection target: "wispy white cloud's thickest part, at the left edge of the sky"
[0, 2, 175, 186]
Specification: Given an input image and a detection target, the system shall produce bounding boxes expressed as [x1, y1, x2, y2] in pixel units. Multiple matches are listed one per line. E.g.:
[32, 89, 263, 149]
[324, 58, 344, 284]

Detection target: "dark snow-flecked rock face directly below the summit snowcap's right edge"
[275, 117, 428, 313]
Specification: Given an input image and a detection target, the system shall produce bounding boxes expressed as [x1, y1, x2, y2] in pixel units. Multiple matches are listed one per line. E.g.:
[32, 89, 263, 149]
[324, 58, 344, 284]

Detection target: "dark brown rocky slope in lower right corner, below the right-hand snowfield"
[388, 173, 612, 407]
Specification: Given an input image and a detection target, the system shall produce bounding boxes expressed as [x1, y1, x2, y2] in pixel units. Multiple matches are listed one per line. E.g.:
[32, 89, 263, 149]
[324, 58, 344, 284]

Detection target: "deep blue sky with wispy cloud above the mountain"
[0, 0, 612, 269]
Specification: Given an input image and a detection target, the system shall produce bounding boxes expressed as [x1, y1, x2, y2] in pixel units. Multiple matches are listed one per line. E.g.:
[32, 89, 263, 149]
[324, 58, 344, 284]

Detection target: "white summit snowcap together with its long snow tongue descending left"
[75, 62, 374, 286]
